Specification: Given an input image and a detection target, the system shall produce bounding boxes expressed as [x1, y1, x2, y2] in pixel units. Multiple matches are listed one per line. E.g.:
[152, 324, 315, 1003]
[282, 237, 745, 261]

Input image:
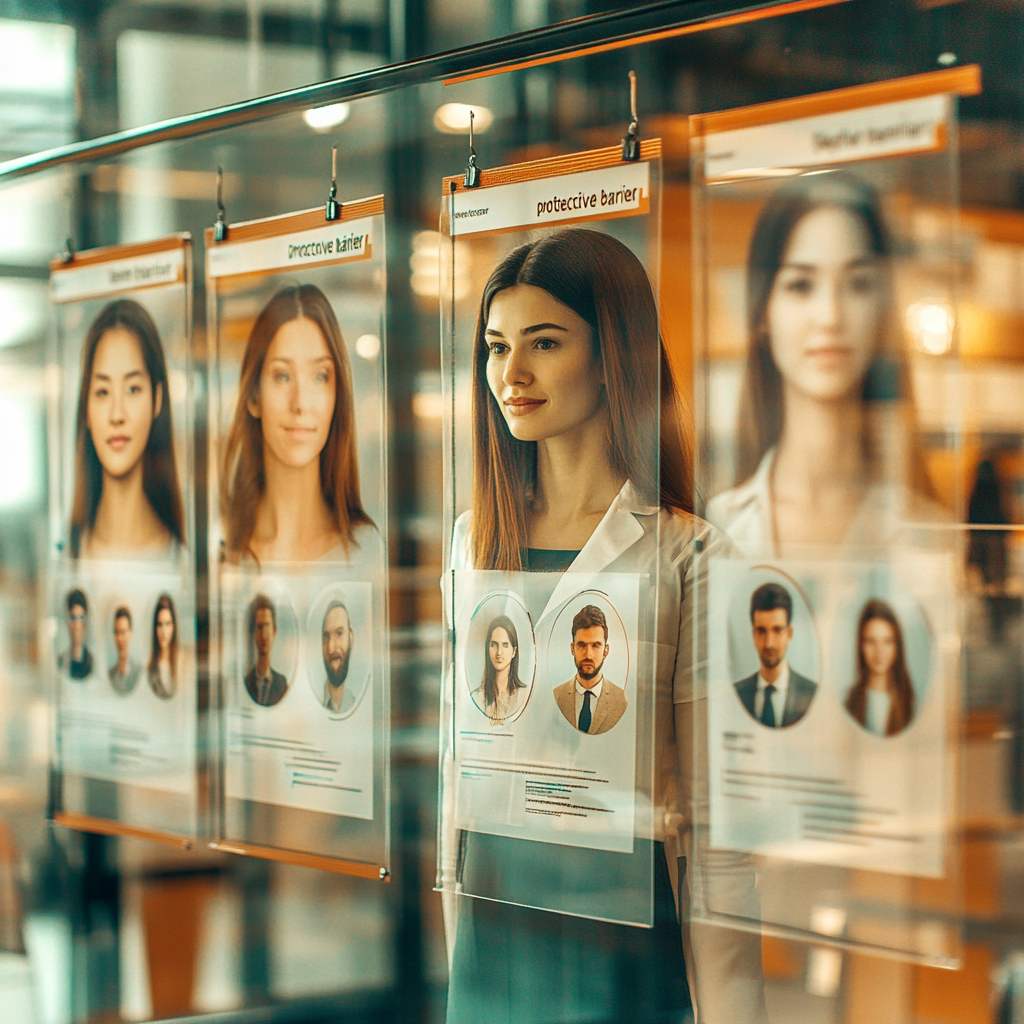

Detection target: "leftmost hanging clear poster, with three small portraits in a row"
[45, 236, 198, 846]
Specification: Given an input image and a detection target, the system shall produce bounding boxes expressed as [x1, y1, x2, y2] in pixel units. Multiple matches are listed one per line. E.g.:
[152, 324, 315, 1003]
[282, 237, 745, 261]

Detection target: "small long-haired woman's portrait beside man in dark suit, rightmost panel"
[845, 598, 914, 736]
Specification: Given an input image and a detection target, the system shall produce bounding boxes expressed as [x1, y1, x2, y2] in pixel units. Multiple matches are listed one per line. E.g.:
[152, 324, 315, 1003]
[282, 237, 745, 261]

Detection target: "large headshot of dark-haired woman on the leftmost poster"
[69, 299, 184, 557]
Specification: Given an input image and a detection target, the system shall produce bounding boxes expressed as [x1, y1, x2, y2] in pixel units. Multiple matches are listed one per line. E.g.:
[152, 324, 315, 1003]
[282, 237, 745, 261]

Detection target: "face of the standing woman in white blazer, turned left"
[484, 285, 605, 441]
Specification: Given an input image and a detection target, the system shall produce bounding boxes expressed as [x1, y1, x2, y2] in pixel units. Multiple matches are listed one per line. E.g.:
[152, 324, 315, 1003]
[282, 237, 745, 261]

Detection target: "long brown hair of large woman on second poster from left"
[220, 285, 373, 559]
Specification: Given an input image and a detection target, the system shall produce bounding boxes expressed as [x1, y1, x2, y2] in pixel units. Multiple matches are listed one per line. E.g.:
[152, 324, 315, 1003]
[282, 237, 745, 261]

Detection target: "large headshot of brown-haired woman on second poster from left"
[221, 284, 374, 563]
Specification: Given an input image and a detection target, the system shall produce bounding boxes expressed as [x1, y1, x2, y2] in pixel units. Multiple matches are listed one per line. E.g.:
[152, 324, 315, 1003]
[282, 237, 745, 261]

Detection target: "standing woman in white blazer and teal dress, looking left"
[442, 228, 766, 1024]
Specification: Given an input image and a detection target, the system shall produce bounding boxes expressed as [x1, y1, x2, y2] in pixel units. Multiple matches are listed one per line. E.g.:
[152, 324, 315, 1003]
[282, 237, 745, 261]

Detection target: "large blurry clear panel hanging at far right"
[692, 75, 963, 966]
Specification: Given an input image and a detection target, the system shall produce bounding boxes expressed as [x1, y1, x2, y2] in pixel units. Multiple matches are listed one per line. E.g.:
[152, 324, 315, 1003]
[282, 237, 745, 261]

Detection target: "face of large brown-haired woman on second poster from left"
[249, 316, 337, 469]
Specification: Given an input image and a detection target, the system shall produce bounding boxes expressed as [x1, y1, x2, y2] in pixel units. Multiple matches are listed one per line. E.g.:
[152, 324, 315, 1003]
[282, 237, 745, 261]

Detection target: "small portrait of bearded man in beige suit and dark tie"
[554, 604, 627, 736]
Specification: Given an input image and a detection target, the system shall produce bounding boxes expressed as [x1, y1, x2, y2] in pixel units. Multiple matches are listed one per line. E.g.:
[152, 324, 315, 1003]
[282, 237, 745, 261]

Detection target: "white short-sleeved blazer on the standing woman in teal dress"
[438, 481, 768, 1024]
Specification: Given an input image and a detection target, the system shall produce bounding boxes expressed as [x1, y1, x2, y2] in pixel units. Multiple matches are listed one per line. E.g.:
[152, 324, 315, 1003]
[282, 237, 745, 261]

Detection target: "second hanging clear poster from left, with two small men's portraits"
[208, 198, 390, 879]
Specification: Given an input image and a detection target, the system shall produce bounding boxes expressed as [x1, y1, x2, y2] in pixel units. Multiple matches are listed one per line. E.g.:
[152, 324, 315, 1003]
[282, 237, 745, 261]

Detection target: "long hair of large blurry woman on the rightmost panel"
[736, 171, 934, 498]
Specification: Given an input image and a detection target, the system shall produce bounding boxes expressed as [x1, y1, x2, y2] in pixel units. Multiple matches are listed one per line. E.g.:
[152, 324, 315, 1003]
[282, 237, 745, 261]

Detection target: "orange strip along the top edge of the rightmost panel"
[690, 65, 981, 136]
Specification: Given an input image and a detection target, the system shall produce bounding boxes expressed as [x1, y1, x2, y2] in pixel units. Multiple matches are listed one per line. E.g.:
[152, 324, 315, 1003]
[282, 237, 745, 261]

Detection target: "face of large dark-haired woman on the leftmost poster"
[86, 327, 163, 478]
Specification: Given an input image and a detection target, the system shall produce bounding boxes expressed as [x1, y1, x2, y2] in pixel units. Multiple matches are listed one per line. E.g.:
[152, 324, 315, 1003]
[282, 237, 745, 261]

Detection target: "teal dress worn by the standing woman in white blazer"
[446, 549, 692, 1024]
